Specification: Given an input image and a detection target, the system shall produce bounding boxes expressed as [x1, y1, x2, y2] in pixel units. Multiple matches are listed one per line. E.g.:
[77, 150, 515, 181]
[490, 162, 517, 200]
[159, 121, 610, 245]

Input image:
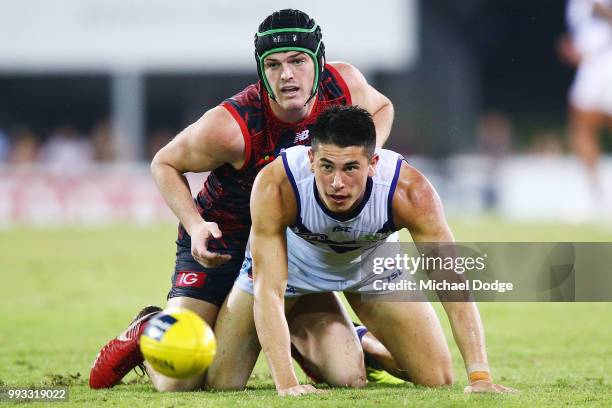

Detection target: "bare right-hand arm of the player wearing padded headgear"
[330, 62, 394, 147]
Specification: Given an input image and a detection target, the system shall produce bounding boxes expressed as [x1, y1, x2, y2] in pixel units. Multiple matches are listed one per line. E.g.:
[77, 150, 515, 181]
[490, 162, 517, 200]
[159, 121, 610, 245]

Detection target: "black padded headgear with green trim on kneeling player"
[255, 9, 325, 103]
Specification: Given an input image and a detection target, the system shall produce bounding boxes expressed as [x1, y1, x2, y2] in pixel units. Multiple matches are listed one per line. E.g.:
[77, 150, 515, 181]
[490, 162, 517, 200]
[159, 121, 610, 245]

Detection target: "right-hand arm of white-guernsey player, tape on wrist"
[393, 163, 514, 393]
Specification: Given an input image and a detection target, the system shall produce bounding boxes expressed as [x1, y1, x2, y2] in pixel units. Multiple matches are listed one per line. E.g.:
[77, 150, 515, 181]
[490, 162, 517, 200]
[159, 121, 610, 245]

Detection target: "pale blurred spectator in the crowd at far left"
[40, 126, 93, 172]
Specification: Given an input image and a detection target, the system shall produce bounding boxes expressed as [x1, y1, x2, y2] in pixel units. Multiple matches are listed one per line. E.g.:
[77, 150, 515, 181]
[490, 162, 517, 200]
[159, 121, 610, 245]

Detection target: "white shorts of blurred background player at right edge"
[569, 49, 612, 115]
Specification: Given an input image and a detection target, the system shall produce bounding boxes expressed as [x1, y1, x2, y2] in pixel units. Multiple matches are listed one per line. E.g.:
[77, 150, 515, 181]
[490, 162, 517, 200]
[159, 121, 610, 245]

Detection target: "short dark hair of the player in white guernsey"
[310, 105, 376, 157]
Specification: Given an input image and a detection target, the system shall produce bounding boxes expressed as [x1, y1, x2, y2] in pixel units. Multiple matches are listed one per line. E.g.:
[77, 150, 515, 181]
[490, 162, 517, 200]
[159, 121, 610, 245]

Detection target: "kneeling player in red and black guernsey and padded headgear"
[89, 9, 393, 391]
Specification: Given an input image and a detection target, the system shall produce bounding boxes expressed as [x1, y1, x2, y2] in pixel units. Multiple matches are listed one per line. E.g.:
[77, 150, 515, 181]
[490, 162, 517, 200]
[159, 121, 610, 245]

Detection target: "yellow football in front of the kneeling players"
[140, 308, 217, 378]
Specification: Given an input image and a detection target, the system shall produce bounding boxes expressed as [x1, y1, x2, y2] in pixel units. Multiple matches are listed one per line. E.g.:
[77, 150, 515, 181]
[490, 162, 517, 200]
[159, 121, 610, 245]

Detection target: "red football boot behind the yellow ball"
[89, 306, 162, 389]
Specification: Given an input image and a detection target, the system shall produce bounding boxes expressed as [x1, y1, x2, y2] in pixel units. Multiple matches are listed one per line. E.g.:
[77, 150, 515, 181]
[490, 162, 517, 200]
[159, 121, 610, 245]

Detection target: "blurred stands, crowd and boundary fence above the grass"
[0, 0, 612, 226]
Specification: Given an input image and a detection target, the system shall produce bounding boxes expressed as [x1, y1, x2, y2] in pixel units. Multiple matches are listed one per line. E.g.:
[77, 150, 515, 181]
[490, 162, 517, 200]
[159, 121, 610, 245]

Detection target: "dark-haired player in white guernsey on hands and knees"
[241, 107, 514, 395]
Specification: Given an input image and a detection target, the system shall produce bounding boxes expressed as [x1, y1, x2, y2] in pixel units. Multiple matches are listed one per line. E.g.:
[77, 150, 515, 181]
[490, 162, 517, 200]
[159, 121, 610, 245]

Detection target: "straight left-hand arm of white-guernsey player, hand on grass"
[250, 159, 315, 396]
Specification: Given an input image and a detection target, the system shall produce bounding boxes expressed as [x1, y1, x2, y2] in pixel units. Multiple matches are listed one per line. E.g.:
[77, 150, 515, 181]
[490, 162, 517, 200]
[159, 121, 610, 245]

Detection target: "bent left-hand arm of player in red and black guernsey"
[151, 107, 245, 267]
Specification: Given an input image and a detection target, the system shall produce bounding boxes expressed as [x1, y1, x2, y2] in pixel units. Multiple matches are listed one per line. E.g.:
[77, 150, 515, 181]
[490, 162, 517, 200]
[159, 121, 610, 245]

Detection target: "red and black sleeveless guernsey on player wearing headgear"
[186, 64, 352, 251]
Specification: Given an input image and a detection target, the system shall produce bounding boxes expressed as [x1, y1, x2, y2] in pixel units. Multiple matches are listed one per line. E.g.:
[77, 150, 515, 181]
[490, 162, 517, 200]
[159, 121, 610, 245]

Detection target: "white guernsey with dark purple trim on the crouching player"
[237, 146, 404, 296]
